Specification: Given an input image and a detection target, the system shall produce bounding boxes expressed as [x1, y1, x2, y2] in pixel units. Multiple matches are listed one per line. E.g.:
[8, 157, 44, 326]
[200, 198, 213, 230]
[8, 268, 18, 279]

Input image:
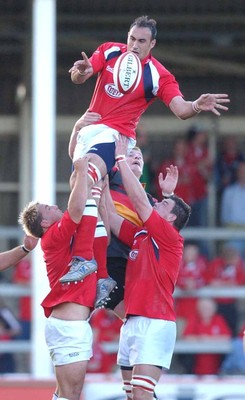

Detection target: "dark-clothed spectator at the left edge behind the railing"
[0, 298, 21, 374]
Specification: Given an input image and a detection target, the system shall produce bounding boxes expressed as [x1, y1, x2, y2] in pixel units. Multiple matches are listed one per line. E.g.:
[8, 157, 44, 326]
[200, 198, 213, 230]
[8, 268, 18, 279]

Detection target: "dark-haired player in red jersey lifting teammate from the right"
[103, 135, 190, 400]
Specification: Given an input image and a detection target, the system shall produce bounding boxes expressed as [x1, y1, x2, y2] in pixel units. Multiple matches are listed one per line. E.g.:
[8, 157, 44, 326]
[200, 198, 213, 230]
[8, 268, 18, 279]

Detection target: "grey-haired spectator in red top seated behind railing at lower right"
[183, 298, 231, 375]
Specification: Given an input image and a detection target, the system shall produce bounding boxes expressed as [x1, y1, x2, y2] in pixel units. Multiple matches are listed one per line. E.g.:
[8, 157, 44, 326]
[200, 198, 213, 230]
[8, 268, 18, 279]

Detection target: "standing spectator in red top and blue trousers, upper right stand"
[186, 126, 213, 226]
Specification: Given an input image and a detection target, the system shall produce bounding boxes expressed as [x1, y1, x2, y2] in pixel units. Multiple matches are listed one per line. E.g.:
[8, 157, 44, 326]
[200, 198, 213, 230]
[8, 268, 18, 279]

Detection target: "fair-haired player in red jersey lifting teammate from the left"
[20, 157, 97, 400]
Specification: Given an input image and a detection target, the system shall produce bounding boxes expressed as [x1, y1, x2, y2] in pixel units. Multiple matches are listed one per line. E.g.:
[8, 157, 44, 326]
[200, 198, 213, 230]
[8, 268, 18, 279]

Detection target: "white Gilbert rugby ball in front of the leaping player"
[113, 51, 142, 94]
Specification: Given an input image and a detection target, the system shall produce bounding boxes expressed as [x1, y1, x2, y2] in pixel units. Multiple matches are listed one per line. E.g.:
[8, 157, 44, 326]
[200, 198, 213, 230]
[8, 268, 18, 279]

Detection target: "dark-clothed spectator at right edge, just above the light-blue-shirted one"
[215, 135, 245, 198]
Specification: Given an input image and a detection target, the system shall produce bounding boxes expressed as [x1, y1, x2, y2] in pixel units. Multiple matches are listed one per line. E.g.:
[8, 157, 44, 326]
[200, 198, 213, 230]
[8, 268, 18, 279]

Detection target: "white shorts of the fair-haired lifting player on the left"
[45, 317, 93, 366]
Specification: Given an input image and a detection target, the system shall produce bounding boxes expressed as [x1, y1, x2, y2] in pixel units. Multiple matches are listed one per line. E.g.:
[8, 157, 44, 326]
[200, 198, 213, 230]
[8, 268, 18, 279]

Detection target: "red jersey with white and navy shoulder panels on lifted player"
[89, 42, 182, 139]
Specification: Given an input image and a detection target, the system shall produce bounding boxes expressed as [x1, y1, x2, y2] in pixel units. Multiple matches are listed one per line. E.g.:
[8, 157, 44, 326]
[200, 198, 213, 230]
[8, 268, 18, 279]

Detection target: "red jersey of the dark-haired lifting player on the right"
[119, 210, 183, 321]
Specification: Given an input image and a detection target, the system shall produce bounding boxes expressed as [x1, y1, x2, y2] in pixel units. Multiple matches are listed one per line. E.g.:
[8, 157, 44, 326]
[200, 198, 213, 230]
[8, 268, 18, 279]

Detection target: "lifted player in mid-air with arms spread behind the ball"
[61, 16, 230, 288]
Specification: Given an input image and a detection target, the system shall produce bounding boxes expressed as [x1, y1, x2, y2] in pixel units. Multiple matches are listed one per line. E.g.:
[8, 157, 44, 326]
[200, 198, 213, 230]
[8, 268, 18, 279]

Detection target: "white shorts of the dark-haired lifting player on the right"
[117, 316, 176, 369]
